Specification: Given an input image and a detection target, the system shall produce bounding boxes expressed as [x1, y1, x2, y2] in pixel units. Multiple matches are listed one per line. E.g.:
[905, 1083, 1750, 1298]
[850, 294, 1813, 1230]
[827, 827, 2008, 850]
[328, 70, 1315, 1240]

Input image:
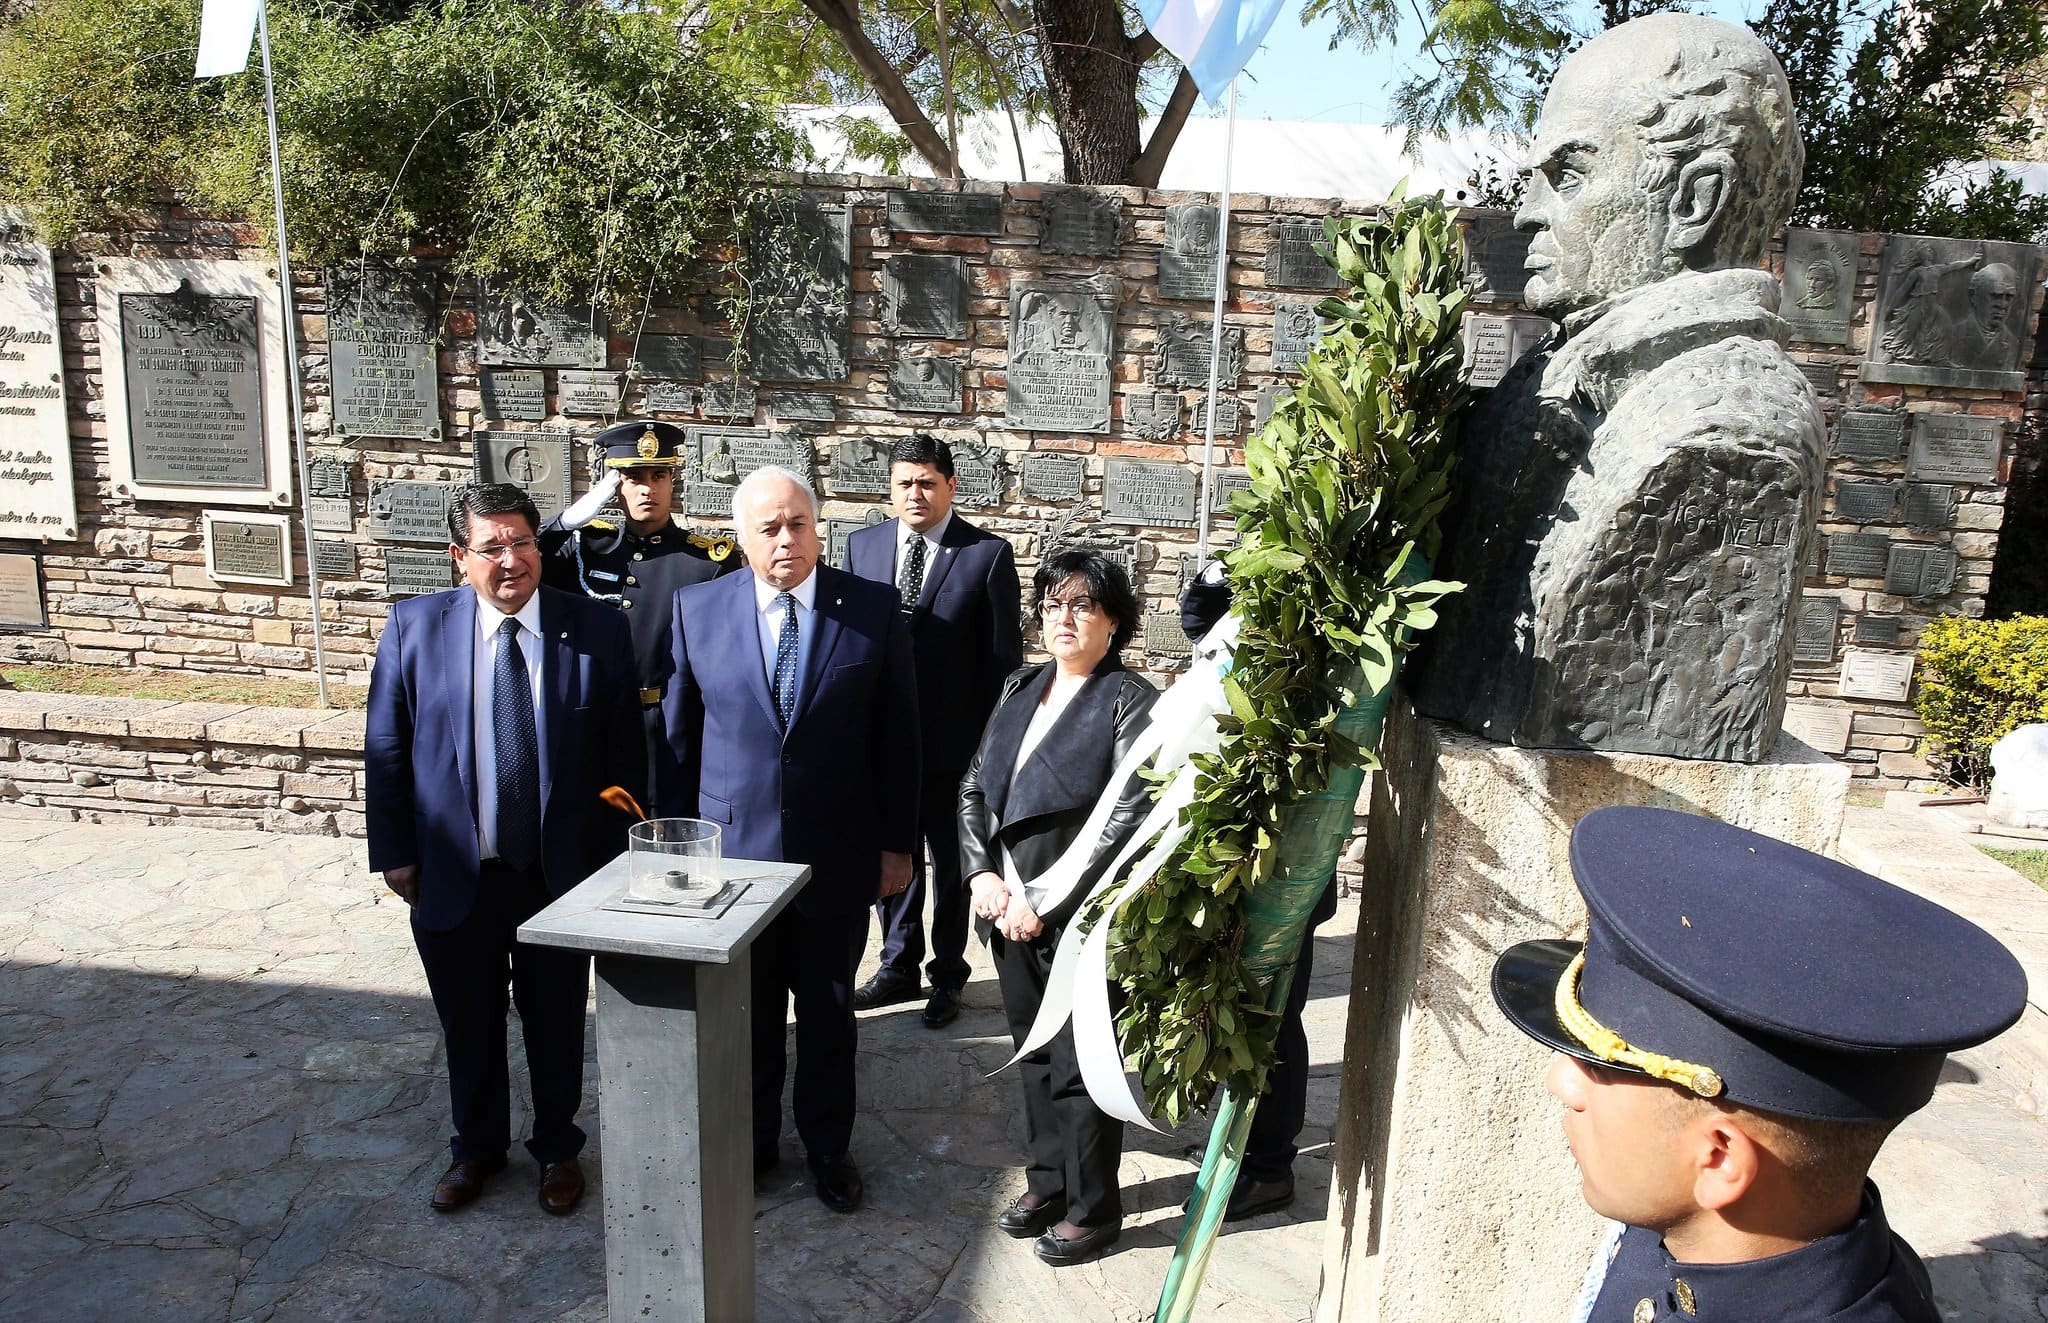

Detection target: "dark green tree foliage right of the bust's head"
[1751, 0, 2048, 242]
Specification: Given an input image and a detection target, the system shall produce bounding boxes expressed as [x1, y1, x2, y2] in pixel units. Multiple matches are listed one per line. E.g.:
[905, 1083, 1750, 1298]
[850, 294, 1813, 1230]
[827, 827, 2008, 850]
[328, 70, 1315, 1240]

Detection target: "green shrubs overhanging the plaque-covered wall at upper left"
[0, 0, 801, 307]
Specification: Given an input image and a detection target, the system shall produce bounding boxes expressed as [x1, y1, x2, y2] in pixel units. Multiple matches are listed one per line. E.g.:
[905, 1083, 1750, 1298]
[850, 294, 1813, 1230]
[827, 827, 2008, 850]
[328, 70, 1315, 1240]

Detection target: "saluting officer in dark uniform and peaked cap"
[541, 422, 739, 788]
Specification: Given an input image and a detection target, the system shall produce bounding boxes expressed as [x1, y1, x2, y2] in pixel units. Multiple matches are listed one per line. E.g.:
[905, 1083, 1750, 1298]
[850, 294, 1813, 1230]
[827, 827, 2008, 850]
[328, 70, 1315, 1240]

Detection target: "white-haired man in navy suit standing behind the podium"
[659, 467, 918, 1212]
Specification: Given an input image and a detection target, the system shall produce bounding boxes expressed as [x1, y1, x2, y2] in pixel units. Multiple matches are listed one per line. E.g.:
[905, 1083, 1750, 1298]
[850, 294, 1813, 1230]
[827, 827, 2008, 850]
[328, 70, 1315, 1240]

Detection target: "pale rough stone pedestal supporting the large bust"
[1317, 698, 1849, 1323]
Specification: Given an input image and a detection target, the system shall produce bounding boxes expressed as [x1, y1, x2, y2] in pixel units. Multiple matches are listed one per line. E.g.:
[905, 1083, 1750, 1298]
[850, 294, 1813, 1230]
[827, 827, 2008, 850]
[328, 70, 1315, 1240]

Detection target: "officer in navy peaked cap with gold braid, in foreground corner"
[1493, 809, 2028, 1323]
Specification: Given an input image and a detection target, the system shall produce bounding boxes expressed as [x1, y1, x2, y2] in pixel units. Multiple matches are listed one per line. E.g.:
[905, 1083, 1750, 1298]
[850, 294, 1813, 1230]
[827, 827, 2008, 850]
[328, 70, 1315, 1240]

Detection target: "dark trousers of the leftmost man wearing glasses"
[412, 858, 590, 1163]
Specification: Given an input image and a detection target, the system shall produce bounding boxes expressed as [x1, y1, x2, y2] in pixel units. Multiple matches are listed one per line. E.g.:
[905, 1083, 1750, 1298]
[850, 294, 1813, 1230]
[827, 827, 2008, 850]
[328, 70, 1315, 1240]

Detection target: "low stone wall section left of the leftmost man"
[0, 692, 362, 836]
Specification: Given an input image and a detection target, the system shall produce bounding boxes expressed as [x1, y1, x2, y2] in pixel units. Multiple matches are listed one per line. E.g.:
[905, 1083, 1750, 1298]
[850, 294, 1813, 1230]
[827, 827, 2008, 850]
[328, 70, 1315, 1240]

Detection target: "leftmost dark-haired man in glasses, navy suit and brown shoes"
[362, 483, 645, 1212]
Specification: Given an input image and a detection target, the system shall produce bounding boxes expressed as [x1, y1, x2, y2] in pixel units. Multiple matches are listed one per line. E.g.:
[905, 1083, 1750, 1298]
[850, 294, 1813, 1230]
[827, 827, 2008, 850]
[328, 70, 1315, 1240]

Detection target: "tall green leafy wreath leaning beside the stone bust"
[1110, 197, 1468, 1124]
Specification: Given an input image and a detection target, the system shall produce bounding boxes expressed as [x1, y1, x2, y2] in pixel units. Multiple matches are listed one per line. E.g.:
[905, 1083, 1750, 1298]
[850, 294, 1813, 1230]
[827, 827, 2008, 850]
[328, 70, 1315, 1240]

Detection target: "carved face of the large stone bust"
[1516, 59, 1669, 313]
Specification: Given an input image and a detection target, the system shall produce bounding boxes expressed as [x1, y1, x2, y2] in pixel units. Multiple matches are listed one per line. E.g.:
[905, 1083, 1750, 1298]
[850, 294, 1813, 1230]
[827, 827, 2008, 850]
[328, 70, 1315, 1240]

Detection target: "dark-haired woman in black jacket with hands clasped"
[961, 551, 1159, 1266]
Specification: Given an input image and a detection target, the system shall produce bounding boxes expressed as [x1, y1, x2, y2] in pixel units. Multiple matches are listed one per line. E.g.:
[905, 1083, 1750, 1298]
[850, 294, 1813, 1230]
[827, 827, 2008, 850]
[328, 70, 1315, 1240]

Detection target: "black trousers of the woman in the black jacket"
[989, 928, 1124, 1227]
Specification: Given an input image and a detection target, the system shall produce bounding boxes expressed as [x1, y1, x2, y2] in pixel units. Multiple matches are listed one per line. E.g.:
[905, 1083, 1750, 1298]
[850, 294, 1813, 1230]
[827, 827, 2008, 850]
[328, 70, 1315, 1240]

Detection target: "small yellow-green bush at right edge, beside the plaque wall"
[1913, 616, 2048, 786]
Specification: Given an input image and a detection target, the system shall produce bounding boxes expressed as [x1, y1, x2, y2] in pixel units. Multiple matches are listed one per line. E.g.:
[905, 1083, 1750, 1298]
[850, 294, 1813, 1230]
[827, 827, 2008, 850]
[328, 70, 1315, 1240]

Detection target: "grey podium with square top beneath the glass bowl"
[518, 854, 811, 1323]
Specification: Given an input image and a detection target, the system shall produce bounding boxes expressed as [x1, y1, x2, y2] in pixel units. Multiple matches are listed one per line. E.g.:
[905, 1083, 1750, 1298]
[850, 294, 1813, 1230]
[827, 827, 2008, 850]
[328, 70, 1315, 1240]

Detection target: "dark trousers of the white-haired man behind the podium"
[752, 909, 868, 1157]
